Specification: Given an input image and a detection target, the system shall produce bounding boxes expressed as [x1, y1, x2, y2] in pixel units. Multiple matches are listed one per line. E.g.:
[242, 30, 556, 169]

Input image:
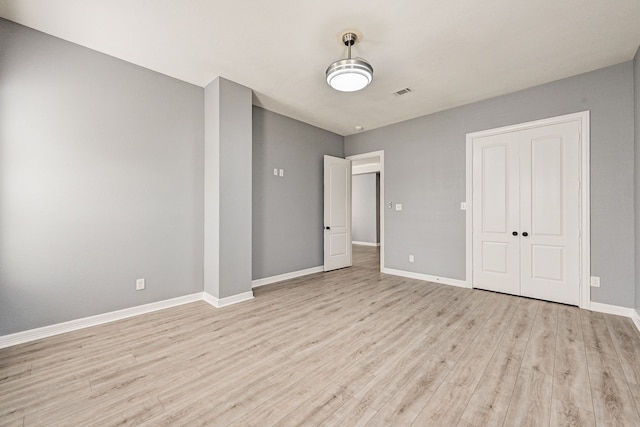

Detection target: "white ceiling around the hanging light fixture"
[0, 0, 640, 135]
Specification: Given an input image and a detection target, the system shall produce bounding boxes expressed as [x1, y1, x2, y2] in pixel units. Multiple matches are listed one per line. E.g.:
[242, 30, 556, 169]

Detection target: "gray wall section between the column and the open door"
[253, 107, 344, 279]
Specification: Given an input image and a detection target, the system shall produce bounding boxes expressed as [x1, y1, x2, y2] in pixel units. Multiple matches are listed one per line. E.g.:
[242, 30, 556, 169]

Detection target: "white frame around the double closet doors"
[466, 111, 591, 309]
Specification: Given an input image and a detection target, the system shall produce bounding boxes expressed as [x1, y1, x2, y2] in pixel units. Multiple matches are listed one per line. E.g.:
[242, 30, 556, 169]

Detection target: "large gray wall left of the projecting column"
[0, 19, 203, 335]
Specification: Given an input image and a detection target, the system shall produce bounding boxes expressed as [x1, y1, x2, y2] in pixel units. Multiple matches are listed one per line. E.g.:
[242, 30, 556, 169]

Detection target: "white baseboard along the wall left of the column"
[0, 293, 202, 348]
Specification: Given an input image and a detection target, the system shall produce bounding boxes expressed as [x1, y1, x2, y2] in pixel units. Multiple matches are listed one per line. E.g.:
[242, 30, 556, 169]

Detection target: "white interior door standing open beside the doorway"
[324, 156, 352, 271]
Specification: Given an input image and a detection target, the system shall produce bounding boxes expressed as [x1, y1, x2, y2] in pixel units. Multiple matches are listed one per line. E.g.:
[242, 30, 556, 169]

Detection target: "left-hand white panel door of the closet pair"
[472, 133, 520, 295]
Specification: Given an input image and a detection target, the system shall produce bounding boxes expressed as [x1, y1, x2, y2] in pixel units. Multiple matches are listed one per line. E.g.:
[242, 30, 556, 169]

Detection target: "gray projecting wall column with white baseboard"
[204, 77, 253, 307]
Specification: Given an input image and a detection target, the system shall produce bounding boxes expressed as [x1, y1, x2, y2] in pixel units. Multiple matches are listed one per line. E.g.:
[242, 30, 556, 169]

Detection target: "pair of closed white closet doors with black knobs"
[472, 121, 580, 305]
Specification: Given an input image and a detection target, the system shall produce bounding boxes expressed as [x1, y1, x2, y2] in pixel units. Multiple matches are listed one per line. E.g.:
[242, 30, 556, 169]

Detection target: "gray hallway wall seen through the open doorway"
[351, 173, 380, 243]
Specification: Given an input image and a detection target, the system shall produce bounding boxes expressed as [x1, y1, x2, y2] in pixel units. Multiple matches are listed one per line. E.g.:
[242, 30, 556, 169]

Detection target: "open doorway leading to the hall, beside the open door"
[347, 151, 384, 270]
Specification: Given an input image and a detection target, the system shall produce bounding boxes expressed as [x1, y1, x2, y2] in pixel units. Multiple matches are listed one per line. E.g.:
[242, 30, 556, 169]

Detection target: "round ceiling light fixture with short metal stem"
[327, 33, 373, 92]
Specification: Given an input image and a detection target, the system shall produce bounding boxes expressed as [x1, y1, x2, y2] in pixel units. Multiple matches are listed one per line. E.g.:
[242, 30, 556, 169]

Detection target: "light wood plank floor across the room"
[0, 246, 640, 427]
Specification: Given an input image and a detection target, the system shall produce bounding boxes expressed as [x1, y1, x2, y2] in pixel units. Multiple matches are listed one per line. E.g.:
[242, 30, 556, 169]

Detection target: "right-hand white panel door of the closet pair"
[520, 122, 580, 305]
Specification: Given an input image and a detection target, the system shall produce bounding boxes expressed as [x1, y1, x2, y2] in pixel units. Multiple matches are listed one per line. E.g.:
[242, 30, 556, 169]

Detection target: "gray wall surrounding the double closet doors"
[345, 62, 635, 307]
